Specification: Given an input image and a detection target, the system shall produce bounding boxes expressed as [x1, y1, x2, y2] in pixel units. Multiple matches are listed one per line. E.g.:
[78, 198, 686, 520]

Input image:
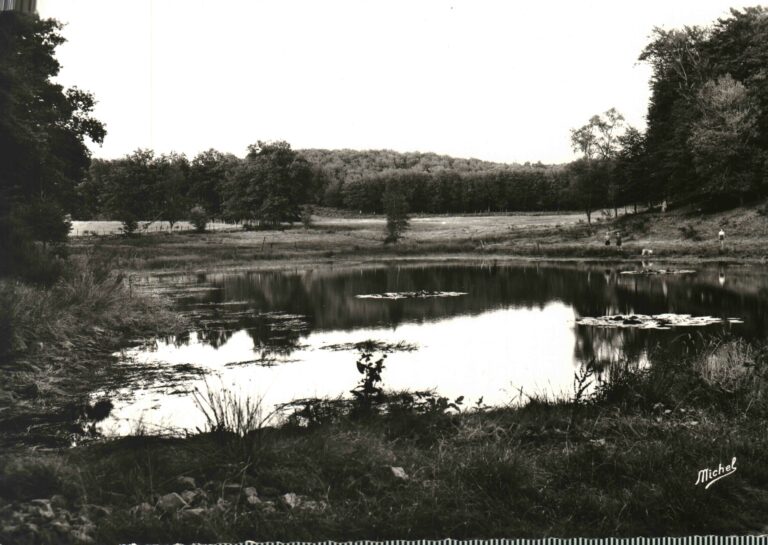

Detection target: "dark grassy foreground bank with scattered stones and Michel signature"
[0, 341, 768, 543]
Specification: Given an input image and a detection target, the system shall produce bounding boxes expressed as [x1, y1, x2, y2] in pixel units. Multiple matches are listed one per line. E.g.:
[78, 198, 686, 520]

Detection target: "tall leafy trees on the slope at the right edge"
[569, 7, 768, 214]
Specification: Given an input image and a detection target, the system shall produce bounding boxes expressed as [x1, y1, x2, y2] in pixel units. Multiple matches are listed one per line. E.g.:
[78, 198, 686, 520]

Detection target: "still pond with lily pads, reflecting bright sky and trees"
[94, 262, 768, 435]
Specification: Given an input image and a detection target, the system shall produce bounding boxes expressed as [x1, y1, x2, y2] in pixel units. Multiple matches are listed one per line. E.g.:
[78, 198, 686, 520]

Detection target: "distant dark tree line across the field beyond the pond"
[75, 147, 576, 225]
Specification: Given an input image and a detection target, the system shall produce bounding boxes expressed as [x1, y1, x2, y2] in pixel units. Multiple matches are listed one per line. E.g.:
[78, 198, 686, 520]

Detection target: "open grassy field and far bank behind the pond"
[64, 207, 768, 272]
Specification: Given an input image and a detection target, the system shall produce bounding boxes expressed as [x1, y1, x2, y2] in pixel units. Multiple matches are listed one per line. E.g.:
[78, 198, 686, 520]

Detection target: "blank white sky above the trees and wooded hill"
[38, 0, 755, 163]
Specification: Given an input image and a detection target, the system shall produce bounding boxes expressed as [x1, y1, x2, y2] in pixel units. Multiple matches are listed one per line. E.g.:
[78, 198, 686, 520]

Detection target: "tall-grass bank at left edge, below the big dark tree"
[0, 252, 183, 448]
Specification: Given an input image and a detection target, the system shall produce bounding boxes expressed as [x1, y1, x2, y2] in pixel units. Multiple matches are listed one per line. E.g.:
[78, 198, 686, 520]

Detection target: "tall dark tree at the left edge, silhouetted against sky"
[0, 11, 106, 274]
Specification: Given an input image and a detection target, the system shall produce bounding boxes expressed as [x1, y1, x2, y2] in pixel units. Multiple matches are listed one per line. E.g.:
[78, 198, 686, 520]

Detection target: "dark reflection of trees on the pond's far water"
[164, 264, 768, 364]
